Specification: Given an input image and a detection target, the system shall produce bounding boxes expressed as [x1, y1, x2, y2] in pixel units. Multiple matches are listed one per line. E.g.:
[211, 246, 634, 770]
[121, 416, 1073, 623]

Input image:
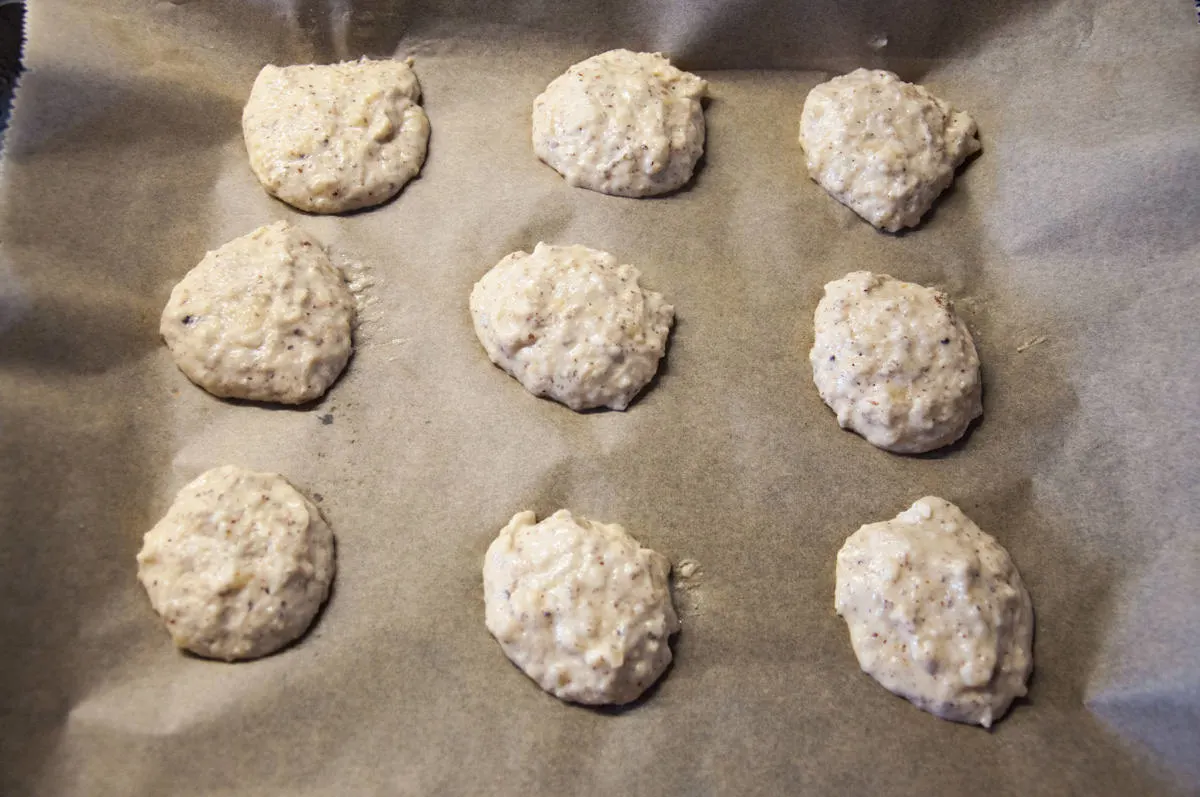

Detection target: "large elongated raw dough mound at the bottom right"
[835, 496, 1033, 727]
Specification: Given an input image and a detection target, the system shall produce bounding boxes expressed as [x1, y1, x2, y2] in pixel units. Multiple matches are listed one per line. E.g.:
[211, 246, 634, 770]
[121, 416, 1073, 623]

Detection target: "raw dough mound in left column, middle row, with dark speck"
[160, 221, 355, 405]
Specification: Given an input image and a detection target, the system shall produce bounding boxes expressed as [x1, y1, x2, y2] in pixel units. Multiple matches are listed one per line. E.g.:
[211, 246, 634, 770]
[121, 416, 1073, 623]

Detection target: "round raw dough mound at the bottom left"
[138, 465, 334, 661]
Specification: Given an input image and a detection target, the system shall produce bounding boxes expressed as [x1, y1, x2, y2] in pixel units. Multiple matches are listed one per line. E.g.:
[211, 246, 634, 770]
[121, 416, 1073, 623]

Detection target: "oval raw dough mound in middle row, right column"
[809, 271, 983, 454]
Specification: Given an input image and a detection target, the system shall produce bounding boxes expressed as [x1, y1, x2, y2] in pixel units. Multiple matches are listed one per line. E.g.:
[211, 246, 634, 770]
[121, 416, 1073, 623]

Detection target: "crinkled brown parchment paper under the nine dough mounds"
[0, 0, 1200, 795]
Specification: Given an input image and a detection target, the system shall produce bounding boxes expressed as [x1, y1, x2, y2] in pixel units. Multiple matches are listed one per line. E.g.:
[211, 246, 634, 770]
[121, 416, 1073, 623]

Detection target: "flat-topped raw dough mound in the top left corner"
[241, 59, 430, 214]
